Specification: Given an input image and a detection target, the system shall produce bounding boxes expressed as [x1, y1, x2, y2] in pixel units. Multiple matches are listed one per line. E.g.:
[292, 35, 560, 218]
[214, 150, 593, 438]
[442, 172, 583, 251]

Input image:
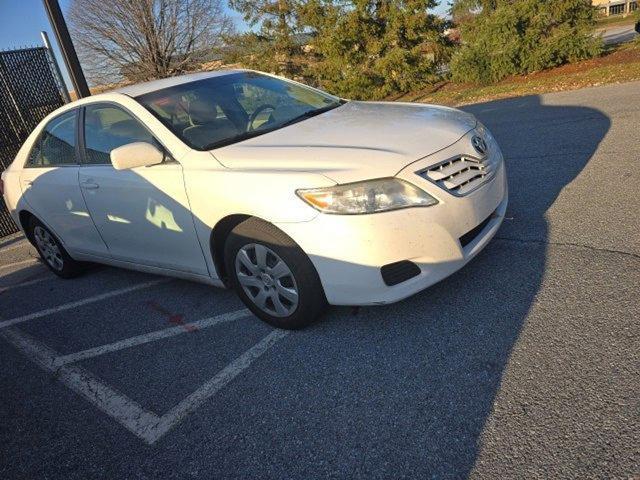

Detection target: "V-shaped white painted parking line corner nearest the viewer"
[0, 328, 289, 444]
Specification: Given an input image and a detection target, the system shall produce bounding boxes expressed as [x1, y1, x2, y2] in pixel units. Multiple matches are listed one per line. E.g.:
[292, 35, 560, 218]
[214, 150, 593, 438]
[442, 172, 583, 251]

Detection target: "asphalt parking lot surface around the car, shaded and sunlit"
[0, 83, 640, 479]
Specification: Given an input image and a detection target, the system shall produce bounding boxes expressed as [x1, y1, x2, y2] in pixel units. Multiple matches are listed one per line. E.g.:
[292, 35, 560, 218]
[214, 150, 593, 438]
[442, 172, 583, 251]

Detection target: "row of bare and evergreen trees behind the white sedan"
[69, 0, 602, 99]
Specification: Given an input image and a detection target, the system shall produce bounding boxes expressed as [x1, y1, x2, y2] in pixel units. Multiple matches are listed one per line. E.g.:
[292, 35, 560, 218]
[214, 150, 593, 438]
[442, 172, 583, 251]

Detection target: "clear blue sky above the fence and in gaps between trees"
[0, 0, 448, 88]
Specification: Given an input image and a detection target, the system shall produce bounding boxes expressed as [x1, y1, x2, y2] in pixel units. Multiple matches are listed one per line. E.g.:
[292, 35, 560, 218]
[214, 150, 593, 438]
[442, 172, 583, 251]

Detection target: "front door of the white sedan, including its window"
[79, 103, 208, 275]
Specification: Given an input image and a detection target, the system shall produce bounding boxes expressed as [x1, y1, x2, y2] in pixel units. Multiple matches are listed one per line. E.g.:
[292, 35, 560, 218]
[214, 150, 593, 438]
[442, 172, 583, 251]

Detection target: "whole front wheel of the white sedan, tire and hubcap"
[225, 218, 327, 329]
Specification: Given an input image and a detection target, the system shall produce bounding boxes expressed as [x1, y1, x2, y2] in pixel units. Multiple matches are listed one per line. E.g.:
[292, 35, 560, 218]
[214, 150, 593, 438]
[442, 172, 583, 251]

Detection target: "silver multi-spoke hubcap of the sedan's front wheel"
[235, 243, 298, 317]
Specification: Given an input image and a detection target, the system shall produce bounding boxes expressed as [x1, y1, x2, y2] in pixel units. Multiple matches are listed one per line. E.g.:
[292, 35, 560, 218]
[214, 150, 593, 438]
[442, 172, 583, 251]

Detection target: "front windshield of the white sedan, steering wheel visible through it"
[136, 72, 344, 150]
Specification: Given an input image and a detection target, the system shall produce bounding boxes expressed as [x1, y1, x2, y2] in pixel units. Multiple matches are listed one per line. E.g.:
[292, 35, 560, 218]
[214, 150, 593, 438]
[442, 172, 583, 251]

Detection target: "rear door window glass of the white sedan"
[26, 110, 77, 167]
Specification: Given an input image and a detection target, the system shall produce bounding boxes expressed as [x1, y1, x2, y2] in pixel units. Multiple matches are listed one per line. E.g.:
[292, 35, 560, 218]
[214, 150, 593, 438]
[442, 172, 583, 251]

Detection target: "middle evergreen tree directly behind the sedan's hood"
[301, 0, 447, 99]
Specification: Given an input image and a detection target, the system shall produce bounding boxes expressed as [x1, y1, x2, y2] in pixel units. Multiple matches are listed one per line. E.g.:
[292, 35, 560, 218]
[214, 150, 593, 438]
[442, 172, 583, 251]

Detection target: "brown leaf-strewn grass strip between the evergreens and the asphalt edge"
[390, 42, 640, 106]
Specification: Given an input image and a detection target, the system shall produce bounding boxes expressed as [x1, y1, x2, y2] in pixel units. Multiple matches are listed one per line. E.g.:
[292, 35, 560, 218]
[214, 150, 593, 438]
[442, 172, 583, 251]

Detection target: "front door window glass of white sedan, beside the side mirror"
[84, 104, 159, 165]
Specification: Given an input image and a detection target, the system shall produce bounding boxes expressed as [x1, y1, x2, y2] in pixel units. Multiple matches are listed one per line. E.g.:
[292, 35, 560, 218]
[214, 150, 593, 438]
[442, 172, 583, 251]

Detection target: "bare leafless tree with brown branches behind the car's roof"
[69, 0, 233, 83]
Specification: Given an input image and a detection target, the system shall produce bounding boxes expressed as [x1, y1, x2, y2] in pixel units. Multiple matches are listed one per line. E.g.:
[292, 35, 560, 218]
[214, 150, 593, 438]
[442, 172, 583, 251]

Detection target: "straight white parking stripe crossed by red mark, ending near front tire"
[53, 309, 251, 368]
